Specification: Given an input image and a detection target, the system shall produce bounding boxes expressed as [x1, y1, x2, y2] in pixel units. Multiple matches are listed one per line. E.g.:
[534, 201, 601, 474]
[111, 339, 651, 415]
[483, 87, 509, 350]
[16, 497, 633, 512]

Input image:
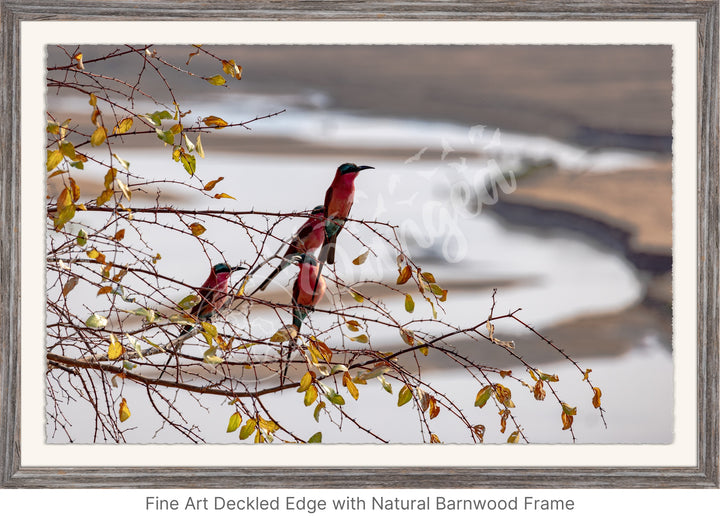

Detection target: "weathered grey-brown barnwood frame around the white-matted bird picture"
[0, 0, 720, 488]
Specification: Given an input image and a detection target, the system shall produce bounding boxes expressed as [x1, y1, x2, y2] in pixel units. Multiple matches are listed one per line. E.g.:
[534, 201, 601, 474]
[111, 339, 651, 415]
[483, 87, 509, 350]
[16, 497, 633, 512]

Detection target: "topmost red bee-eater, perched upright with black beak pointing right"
[320, 163, 374, 264]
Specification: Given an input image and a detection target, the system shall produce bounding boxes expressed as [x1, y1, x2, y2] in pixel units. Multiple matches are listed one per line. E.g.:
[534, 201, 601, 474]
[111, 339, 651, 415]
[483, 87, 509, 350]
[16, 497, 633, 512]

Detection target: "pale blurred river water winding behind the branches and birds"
[49, 93, 673, 443]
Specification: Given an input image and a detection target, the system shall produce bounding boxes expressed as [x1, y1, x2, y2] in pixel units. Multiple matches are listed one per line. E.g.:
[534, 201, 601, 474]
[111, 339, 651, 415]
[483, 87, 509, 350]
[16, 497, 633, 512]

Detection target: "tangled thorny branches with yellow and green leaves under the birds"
[46, 46, 604, 443]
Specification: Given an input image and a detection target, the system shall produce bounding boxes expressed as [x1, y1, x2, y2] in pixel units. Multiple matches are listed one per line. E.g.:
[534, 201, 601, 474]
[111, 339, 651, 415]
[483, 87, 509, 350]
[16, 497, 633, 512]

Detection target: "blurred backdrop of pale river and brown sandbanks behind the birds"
[47, 46, 673, 443]
